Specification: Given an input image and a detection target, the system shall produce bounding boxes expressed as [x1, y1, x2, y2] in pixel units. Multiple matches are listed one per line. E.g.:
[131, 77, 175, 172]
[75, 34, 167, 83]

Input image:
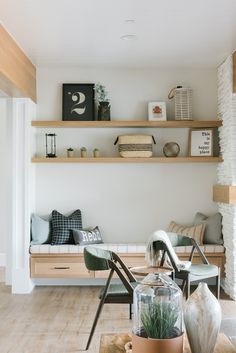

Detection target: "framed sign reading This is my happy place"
[189, 129, 213, 157]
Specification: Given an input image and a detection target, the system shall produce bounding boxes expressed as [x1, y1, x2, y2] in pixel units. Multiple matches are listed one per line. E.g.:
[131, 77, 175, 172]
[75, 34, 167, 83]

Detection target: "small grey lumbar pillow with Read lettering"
[72, 227, 103, 245]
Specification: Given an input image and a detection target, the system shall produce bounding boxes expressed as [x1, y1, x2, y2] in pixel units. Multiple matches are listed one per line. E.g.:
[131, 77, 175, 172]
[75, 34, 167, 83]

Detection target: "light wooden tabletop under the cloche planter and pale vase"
[99, 333, 236, 353]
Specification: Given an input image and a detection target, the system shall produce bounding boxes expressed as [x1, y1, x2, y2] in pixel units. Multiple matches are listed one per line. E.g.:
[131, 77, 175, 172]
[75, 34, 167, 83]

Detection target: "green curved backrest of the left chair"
[84, 246, 112, 271]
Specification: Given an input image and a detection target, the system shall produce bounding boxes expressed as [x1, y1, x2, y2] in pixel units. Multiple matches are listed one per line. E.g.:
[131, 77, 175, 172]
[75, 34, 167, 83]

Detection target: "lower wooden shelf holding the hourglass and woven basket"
[32, 157, 222, 163]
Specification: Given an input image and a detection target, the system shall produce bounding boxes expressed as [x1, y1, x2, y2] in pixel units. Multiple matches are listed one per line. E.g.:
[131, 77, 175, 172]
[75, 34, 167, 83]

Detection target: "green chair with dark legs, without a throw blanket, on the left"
[84, 246, 138, 350]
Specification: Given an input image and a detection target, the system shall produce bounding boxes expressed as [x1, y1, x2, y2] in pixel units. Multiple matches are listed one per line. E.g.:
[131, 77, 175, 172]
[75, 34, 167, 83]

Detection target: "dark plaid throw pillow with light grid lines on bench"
[51, 210, 82, 245]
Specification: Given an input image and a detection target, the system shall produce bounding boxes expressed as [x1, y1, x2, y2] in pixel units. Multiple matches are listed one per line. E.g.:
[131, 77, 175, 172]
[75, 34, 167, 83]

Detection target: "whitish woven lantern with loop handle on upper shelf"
[168, 86, 193, 120]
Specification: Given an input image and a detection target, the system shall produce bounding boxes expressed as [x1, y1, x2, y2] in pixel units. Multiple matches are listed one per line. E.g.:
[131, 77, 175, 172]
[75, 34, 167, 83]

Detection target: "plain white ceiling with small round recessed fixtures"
[0, 0, 236, 68]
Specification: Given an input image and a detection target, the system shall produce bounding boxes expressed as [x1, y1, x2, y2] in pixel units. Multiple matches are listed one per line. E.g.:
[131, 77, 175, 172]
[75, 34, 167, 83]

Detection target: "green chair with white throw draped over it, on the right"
[153, 233, 220, 299]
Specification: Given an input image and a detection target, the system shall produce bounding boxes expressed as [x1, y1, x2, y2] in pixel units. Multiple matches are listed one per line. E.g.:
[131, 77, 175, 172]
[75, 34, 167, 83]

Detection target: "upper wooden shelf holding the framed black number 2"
[31, 120, 222, 128]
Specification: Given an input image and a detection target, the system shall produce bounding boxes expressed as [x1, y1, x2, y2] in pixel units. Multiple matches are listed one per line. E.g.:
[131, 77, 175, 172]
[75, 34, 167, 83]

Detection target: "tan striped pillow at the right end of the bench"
[168, 221, 206, 245]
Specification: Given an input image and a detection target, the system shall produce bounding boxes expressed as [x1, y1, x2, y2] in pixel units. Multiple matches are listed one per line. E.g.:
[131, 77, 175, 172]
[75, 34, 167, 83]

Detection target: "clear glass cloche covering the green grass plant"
[133, 274, 183, 339]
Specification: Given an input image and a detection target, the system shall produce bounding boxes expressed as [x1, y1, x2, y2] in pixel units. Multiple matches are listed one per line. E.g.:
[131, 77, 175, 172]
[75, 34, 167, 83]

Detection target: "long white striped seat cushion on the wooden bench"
[30, 243, 225, 254]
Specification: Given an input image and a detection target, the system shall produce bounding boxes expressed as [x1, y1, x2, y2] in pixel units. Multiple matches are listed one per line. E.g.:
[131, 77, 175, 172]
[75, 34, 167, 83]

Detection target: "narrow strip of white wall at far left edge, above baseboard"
[0, 98, 7, 266]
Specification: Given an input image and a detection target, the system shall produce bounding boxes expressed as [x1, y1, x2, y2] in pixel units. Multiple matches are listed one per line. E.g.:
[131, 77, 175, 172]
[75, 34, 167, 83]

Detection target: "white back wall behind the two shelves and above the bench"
[35, 67, 217, 242]
